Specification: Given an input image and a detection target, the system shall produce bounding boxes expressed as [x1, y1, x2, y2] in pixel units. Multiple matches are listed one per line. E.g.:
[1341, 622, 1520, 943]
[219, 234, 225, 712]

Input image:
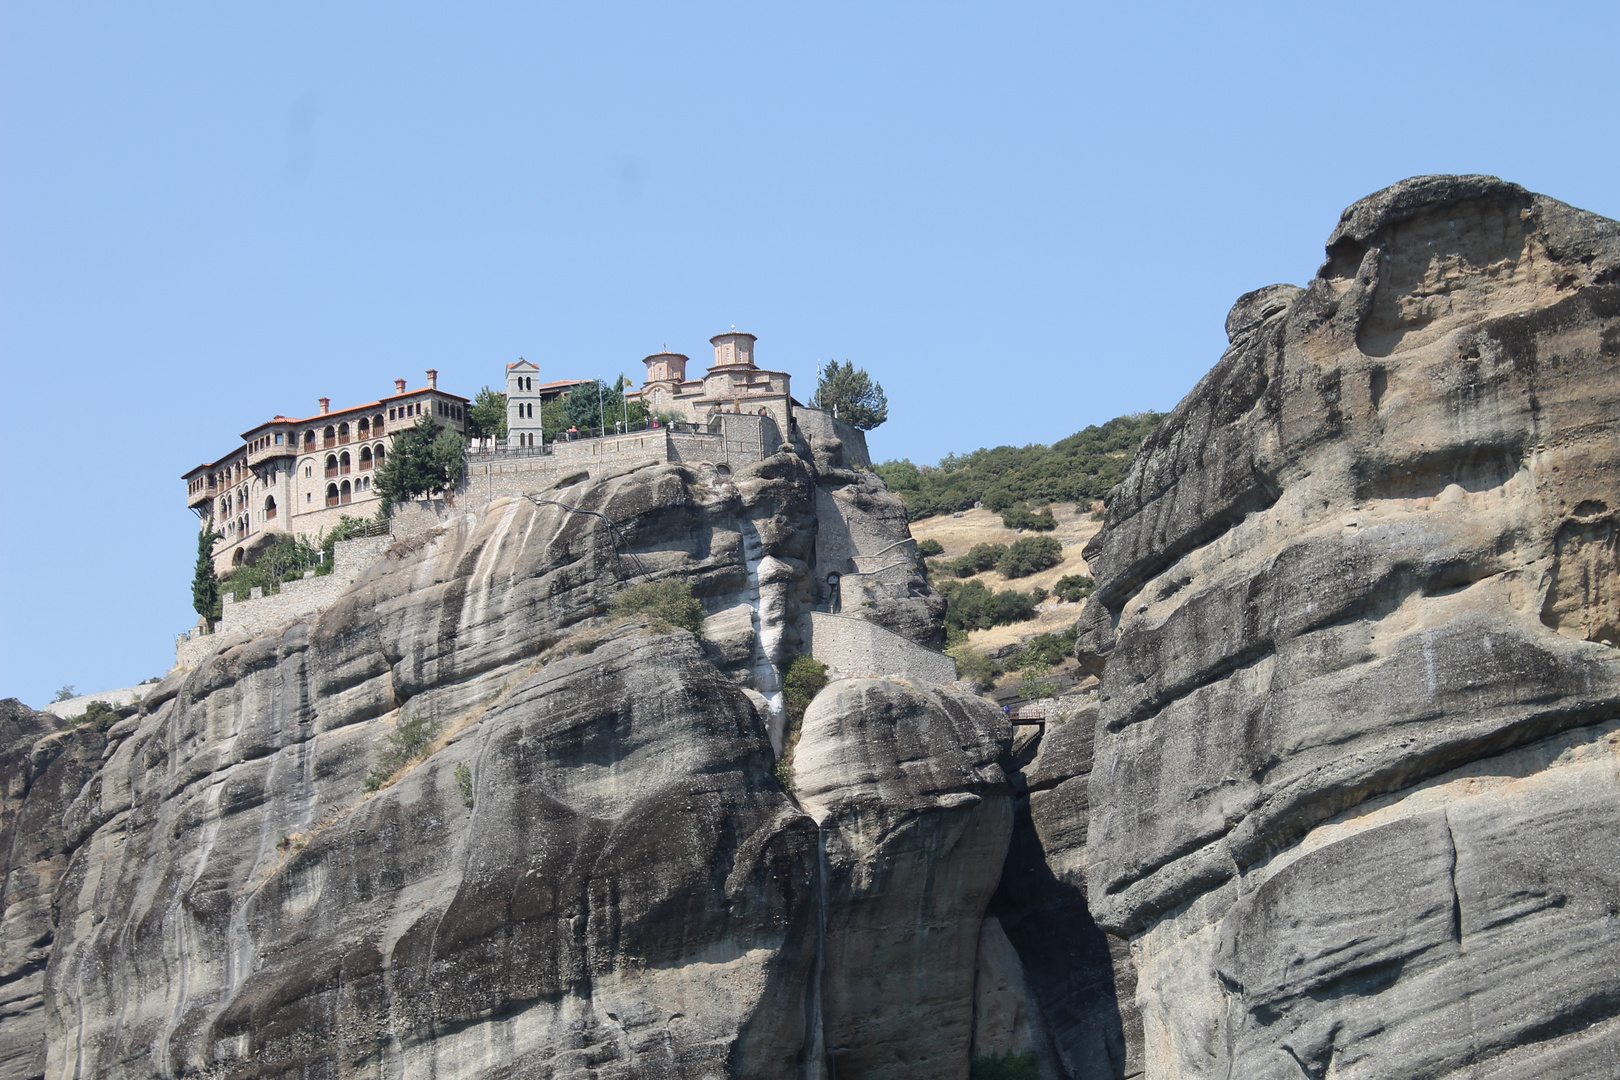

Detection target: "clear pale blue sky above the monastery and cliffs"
[0, 2, 1620, 706]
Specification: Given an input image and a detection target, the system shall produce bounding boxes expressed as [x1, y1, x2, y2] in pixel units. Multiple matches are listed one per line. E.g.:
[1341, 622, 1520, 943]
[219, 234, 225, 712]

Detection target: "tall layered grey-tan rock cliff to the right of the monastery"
[1079, 176, 1620, 1080]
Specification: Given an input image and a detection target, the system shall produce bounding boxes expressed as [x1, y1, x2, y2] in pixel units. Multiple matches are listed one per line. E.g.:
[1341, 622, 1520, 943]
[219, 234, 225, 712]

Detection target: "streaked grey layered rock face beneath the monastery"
[15, 447, 1036, 1080]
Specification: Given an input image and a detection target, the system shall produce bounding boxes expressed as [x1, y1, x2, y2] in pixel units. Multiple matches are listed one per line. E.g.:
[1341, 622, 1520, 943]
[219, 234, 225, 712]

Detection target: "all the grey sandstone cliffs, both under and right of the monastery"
[9, 176, 1620, 1080]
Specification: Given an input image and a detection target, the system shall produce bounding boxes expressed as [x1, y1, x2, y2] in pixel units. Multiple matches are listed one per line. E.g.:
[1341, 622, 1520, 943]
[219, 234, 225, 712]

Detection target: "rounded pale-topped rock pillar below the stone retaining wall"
[794, 678, 1016, 1080]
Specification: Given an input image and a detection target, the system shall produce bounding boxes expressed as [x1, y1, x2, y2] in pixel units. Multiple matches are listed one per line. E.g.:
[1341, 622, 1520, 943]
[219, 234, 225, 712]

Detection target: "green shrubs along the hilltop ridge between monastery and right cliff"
[876, 413, 1162, 528]
